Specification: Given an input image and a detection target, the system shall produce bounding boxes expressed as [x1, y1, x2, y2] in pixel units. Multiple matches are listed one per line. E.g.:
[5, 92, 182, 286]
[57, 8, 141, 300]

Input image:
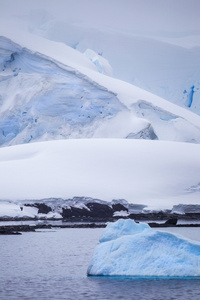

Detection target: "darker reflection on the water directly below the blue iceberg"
[87, 278, 200, 300]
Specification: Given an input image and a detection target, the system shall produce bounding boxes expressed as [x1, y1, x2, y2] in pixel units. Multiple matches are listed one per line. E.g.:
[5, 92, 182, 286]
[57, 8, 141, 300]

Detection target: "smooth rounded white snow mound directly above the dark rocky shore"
[0, 139, 200, 209]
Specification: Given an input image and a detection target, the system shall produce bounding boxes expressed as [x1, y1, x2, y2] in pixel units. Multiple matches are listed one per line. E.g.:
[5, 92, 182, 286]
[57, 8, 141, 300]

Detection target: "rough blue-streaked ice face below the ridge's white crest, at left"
[0, 38, 123, 145]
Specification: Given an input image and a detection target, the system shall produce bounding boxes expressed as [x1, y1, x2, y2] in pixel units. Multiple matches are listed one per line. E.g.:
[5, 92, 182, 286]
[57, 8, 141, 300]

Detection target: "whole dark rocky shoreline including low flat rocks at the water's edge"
[0, 197, 200, 235]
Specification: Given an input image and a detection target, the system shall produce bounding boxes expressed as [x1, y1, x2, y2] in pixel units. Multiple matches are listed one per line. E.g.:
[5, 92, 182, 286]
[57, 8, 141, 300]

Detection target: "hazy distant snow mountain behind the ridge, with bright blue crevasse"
[30, 11, 200, 114]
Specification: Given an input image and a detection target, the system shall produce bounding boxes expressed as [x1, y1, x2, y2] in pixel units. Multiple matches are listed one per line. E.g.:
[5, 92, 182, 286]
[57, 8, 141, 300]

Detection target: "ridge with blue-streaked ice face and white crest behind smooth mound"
[0, 37, 200, 145]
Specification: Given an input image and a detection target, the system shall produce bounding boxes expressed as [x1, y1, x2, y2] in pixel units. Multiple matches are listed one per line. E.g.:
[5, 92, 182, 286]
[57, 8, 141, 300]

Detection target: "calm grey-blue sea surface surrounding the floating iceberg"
[0, 228, 200, 300]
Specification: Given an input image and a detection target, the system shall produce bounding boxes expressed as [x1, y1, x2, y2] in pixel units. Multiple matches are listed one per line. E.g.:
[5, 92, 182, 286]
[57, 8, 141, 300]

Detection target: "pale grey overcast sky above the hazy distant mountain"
[0, 0, 200, 32]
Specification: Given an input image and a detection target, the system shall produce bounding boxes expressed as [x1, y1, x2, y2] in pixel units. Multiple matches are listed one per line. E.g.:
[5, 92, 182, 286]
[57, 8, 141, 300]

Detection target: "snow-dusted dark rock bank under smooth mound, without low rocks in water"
[0, 197, 200, 226]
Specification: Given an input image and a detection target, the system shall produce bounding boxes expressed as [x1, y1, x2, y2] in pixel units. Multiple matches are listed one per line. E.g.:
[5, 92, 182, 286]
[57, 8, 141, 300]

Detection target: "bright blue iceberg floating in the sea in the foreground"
[87, 219, 200, 277]
